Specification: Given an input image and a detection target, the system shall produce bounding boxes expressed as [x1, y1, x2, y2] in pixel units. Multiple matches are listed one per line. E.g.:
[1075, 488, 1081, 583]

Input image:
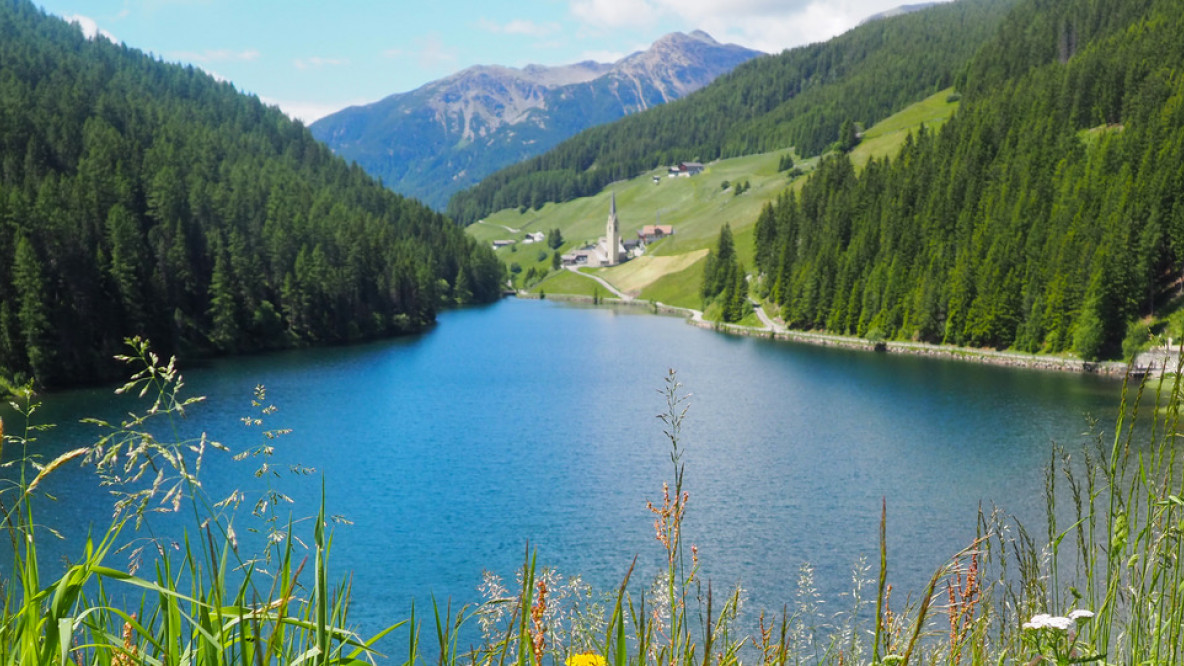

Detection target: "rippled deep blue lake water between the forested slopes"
[0, 300, 1120, 649]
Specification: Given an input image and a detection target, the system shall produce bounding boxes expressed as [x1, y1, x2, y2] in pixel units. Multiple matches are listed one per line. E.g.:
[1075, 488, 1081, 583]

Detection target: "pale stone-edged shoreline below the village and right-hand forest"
[516, 293, 1130, 378]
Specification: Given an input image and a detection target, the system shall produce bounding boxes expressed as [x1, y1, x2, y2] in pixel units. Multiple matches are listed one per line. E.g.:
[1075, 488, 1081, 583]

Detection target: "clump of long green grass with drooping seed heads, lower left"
[0, 340, 398, 666]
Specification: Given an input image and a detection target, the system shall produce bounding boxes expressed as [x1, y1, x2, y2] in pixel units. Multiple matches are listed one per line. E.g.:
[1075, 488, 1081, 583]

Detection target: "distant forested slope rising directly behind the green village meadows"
[448, 0, 1015, 224]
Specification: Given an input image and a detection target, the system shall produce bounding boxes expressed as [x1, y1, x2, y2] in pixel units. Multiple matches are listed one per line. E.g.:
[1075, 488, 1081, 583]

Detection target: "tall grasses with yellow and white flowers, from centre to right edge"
[426, 372, 1184, 666]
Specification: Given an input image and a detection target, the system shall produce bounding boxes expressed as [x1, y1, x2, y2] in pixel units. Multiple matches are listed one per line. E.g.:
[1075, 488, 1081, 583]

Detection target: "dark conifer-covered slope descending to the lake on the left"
[0, 0, 501, 386]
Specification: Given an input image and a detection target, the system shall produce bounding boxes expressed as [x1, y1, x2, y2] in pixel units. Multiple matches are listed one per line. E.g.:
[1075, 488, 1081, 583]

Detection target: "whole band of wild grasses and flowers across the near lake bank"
[0, 341, 1184, 666]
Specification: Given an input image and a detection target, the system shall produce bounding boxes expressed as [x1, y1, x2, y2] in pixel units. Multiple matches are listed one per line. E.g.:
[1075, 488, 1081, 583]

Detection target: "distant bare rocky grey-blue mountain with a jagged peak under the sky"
[310, 31, 761, 209]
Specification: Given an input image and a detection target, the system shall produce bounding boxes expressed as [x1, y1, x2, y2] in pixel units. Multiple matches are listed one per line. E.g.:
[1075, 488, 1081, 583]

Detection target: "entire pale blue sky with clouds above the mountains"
[34, 0, 947, 123]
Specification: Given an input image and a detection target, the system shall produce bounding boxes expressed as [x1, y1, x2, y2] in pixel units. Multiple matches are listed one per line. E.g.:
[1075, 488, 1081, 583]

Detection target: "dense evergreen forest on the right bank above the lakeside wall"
[755, 0, 1184, 359]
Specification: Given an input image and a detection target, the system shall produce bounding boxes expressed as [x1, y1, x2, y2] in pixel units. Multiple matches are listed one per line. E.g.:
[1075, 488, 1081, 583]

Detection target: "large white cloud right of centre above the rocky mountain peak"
[568, 0, 942, 53]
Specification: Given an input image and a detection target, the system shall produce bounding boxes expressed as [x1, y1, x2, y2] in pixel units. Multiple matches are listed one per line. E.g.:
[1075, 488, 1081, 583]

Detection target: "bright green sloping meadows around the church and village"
[468, 90, 958, 308]
